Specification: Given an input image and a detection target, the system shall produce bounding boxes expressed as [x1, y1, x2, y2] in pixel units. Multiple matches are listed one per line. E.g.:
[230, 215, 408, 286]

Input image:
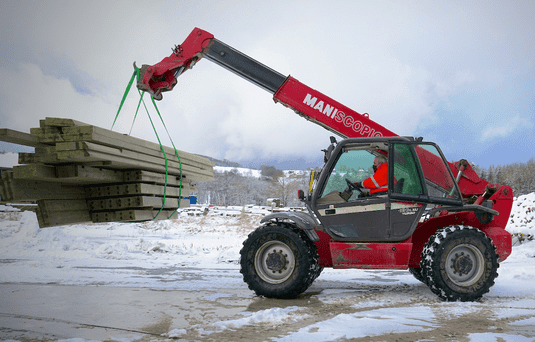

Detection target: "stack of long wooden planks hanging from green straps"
[0, 118, 214, 227]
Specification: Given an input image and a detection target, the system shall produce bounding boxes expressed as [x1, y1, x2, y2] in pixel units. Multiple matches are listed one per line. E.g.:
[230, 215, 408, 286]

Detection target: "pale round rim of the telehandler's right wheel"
[446, 244, 485, 286]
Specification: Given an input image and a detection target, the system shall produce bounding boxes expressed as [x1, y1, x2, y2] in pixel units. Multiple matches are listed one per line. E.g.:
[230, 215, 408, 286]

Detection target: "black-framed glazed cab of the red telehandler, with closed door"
[306, 137, 463, 242]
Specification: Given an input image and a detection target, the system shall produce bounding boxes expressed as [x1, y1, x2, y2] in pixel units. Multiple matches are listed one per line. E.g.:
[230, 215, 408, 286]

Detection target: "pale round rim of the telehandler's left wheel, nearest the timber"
[254, 241, 295, 284]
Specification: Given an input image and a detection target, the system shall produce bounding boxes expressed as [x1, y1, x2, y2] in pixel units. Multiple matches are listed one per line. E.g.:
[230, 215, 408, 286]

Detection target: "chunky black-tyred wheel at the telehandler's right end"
[420, 226, 499, 302]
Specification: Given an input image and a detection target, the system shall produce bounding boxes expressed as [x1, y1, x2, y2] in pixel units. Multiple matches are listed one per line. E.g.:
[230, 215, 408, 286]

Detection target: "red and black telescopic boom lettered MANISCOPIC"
[137, 28, 512, 203]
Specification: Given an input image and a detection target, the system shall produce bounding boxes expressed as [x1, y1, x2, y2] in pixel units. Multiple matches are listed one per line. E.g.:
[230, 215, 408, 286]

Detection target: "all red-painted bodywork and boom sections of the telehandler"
[138, 28, 513, 268]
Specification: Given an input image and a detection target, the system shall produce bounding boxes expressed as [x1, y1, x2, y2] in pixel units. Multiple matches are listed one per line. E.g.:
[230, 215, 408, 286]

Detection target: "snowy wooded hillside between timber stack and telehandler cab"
[196, 165, 308, 206]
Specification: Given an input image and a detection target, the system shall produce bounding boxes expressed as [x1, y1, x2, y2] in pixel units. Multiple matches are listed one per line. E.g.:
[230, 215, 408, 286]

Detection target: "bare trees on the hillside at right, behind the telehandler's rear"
[474, 158, 535, 196]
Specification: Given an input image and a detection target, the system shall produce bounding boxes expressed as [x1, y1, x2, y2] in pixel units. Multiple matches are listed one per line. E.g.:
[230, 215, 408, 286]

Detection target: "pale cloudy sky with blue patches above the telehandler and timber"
[0, 0, 535, 167]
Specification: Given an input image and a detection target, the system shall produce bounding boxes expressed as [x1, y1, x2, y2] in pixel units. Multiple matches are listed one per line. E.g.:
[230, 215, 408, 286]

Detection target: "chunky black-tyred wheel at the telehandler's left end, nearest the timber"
[240, 224, 321, 298]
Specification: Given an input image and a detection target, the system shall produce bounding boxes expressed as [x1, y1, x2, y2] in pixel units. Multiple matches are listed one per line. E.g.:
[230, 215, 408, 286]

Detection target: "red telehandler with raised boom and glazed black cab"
[137, 28, 513, 301]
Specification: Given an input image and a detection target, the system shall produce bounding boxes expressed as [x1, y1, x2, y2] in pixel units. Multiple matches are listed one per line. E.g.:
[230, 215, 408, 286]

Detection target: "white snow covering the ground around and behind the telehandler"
[0, 193, 535, 341]
